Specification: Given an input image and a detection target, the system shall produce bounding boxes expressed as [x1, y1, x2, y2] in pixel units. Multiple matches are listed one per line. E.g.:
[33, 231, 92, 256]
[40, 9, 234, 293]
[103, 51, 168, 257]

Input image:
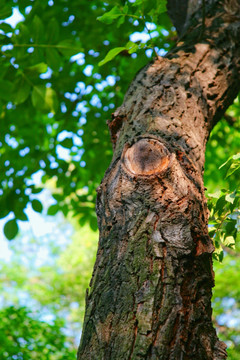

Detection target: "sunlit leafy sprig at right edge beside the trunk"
[208, 153, 240, 262]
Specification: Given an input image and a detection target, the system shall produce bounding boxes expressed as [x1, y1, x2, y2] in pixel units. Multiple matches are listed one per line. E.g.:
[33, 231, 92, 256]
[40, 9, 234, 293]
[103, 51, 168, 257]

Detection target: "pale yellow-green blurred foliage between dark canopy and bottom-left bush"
[0, 217, 97, 330]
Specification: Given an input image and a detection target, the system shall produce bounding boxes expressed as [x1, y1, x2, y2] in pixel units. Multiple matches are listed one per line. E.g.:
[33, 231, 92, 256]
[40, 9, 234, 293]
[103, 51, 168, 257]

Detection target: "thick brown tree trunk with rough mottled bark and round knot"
[78, 1, 240, 360]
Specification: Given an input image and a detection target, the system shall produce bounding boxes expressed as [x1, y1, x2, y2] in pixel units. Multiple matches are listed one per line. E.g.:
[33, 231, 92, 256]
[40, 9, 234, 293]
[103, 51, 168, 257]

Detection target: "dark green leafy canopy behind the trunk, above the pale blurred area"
[0, 1, 239, 358]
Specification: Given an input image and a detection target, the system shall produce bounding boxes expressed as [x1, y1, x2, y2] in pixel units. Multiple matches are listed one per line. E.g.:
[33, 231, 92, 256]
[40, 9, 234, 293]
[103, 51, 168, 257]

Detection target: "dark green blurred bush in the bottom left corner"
[0, 306, 75, 360]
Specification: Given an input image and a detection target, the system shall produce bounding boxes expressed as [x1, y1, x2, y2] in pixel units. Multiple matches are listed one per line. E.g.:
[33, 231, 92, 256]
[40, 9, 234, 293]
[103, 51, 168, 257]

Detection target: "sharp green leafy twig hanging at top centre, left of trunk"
[97, 0, 167, 66]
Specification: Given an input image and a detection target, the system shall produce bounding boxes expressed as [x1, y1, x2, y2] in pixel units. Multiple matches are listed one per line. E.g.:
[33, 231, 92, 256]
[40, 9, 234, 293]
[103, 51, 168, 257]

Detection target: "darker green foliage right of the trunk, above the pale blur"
[205, 98, 240, 261]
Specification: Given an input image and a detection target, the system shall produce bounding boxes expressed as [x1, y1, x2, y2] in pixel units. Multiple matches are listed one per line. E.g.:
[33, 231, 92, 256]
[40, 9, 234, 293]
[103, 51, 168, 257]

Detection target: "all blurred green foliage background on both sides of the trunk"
[0, 0, 240, 360]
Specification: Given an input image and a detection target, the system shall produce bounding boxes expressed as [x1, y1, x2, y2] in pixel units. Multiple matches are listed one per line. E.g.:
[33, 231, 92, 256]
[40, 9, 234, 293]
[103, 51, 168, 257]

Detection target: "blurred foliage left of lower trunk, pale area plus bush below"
[0, 219, 97, 360]
